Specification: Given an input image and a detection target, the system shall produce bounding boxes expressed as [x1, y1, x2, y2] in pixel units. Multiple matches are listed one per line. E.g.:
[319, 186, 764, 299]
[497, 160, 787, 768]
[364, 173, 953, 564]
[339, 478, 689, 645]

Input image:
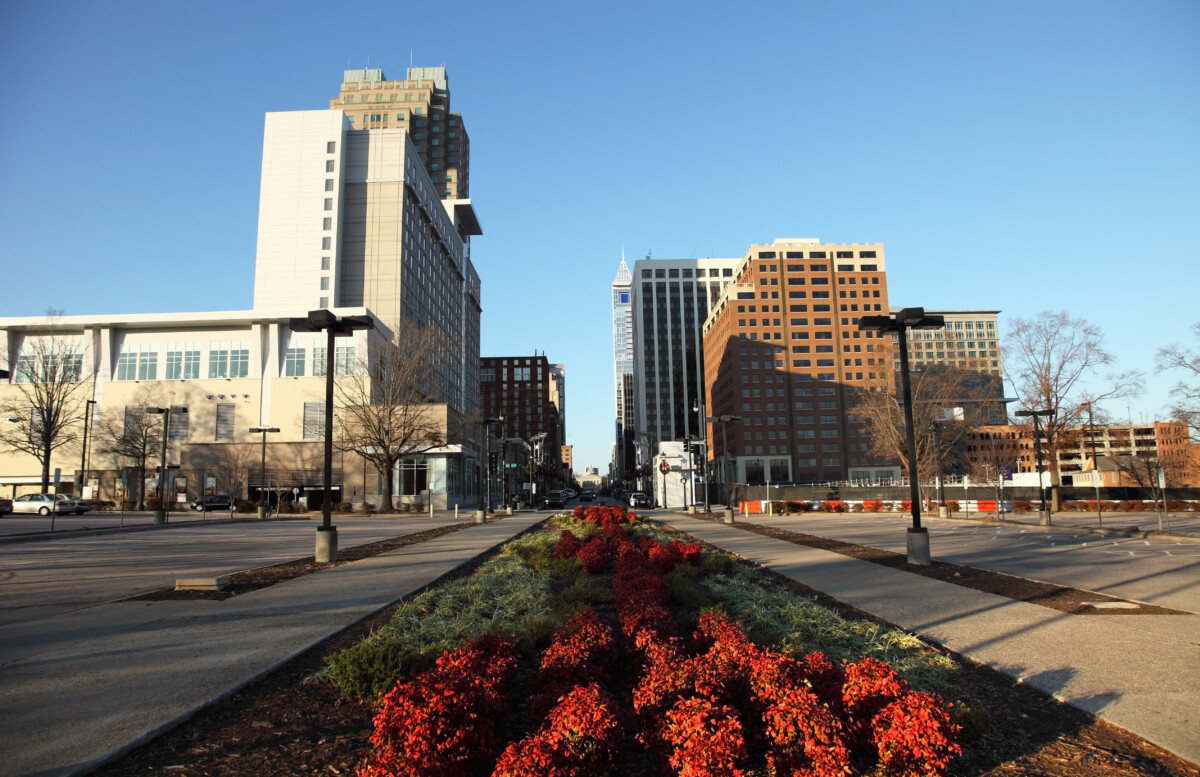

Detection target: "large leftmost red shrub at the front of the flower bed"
[359, 636, 517, 777]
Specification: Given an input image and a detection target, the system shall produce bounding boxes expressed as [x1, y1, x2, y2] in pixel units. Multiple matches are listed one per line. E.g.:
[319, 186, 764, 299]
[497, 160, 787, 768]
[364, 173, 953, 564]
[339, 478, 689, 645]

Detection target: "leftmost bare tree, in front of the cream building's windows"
[0, 309, 92, 492]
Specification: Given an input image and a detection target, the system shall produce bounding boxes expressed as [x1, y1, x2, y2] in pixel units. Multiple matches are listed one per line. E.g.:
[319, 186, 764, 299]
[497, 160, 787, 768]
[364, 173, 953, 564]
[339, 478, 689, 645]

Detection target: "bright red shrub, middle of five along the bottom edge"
[664, 699, 746, 777]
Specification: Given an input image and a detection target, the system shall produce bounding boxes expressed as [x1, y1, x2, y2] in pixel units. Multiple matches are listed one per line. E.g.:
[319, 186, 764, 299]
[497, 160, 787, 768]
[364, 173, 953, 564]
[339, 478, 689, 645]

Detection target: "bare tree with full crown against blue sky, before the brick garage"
[1003, 312, 1142, 511]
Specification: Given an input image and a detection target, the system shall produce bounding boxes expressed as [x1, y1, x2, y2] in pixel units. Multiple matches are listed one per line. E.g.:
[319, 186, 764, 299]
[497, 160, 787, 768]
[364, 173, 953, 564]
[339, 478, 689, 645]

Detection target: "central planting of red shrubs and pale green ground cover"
[316, 506, 970, 777]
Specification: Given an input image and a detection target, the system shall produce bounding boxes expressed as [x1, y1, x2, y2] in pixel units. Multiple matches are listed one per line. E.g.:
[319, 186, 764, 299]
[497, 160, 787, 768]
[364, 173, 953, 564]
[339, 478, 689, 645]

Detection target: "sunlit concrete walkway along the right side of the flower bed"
[660, 514, 1200, 763]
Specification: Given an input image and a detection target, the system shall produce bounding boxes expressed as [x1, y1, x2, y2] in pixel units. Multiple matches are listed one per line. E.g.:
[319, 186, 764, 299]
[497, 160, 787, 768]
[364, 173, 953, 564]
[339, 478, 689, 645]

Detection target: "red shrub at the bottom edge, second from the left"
[492, 683, 620, 777]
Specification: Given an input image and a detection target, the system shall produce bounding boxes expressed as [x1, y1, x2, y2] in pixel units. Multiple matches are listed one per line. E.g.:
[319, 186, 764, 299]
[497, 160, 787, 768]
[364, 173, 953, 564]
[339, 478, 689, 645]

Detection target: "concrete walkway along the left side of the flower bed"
[0, 513, 548, 777]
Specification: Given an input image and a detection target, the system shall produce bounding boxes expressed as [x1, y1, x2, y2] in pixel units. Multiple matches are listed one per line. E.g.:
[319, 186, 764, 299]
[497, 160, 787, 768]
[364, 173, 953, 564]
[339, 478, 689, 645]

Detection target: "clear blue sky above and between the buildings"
[0, 0, 1200, 471]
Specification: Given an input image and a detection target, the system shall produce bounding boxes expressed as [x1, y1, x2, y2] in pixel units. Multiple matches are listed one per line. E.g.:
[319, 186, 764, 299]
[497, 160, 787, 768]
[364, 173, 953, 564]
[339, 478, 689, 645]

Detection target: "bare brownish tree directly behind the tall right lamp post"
[853, 365, 1000, 498]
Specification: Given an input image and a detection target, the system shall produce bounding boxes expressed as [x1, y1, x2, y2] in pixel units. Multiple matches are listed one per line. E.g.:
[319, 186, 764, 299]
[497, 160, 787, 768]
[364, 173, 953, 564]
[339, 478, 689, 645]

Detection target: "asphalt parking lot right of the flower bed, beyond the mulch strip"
[739, 513, 1200, 613]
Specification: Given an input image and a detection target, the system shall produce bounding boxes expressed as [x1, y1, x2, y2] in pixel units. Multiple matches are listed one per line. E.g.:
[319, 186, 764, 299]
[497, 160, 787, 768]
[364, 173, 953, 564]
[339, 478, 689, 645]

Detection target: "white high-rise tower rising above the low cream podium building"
[254, 110, 481, 412]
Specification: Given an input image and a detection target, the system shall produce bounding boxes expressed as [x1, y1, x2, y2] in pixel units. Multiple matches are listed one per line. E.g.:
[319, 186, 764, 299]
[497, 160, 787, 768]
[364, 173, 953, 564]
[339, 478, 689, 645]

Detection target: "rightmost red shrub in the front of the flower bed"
[872, 691, 962, 777]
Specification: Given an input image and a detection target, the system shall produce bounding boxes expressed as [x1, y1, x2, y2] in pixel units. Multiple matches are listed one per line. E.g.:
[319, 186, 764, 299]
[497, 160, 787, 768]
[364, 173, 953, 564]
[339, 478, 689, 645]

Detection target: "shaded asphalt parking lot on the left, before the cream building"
[0, 513, 458, 628]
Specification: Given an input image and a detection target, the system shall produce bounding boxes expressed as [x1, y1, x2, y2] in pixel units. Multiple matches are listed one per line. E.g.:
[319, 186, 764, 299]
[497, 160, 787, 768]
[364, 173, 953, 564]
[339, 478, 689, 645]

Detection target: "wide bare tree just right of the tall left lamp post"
[334, 323, 448, 512]
